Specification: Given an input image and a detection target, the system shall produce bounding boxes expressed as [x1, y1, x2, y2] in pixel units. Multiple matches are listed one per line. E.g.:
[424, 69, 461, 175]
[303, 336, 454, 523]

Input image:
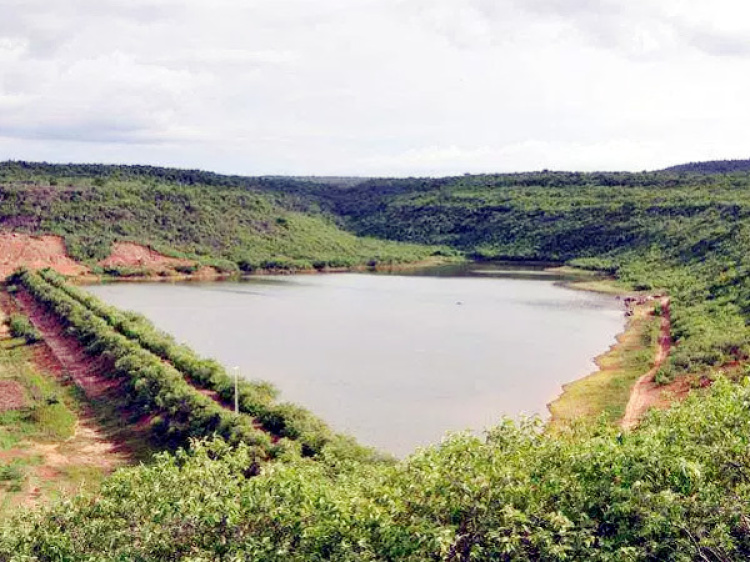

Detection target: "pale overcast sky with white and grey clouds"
[0, 0, 750, 176]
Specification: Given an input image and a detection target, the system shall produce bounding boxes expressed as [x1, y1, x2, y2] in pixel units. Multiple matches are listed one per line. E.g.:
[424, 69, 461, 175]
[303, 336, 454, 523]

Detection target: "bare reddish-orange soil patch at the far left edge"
[0, 232, 88, 279]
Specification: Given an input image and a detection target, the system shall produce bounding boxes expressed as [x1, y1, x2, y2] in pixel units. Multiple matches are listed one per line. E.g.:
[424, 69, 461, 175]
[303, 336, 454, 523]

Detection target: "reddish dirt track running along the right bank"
[620, 297, 686, 429]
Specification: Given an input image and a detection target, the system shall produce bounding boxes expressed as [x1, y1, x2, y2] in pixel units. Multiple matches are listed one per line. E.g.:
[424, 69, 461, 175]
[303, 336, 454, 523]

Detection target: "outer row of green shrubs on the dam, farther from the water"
[9, 270, 290, 458]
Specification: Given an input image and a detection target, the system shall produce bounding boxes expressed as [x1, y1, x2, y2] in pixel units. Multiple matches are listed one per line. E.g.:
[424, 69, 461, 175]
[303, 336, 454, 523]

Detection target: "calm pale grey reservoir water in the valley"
[87, 265, 624, 456]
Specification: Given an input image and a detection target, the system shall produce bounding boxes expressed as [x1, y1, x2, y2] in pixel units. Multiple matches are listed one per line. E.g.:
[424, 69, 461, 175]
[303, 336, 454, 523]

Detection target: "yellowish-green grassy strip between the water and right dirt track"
[549, 303, 660, 424]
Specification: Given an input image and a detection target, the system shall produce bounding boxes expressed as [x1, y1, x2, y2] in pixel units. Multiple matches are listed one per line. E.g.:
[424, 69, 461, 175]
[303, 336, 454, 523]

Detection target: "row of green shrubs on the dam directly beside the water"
[39, 270, 334, 455]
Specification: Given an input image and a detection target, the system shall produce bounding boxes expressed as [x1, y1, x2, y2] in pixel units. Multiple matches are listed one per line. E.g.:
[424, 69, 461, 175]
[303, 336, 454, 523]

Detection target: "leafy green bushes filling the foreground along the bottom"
[0, 379, 750, 562]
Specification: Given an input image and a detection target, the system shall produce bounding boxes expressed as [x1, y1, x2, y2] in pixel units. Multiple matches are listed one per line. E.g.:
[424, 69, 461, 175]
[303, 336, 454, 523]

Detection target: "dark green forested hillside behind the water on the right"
[262, 172, 750, 377]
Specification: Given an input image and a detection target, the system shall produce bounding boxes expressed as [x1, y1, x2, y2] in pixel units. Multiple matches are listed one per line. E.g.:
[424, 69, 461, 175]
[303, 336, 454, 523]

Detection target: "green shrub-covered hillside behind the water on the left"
[0, 162, 436, 273]
